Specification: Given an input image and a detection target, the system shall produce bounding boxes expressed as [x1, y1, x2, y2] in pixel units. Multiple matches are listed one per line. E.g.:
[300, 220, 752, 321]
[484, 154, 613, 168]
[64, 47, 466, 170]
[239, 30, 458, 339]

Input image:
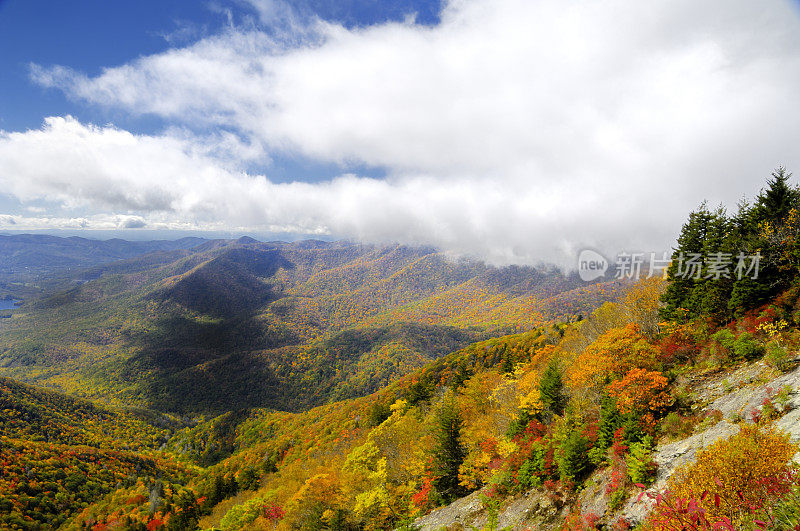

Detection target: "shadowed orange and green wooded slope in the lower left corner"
[0, 378, 196, 529]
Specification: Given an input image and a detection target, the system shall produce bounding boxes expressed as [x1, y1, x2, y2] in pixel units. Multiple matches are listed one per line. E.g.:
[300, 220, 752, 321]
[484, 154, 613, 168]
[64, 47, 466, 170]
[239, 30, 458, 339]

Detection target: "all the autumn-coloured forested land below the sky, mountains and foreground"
[0, 172, 800, 531]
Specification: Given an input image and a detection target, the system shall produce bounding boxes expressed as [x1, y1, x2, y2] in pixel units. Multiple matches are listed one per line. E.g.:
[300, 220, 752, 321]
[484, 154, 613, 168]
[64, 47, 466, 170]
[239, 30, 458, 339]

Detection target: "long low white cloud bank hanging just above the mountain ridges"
[0, 117, 656, 263]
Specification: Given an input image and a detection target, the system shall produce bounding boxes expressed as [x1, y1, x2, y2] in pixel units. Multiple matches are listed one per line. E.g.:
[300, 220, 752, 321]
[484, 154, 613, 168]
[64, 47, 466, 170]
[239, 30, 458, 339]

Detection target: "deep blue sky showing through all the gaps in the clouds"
[0, 0, 441, 183]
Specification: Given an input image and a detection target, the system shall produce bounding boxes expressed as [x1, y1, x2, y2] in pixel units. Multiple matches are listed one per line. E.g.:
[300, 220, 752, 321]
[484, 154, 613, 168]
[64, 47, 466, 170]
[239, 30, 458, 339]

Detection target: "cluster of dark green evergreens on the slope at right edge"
[662, 168, 800, 323]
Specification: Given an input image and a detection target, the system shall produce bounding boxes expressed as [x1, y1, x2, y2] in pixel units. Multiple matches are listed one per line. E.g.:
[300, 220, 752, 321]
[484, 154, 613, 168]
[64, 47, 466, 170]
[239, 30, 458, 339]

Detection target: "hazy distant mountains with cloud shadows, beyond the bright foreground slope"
[0, 236, 622, 414]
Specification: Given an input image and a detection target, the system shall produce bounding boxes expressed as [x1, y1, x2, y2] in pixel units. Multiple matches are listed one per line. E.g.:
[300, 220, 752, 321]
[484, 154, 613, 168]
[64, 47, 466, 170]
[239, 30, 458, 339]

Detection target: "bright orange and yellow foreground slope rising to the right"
[144, 172, 800, 530]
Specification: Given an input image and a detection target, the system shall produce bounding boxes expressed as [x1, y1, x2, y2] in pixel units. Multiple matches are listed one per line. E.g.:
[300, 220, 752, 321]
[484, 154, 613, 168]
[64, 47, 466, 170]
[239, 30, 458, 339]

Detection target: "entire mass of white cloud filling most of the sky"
[14, 0, 800, 262]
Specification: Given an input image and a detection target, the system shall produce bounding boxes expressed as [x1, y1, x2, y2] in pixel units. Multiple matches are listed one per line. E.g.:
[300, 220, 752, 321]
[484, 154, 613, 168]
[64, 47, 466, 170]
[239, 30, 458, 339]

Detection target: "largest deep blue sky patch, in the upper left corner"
[0, 0, 212, 130]
